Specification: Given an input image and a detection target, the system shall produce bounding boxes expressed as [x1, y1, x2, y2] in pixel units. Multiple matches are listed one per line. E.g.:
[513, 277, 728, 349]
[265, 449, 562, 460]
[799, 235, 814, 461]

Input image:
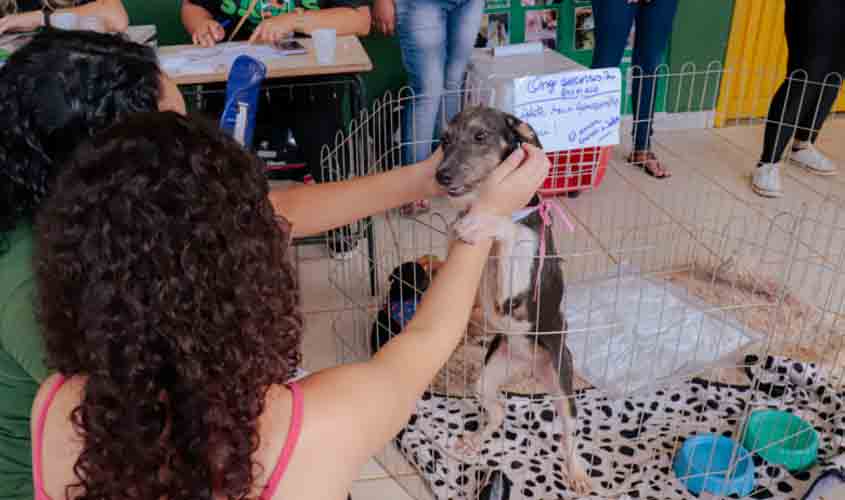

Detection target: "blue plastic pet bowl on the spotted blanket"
[674, 434, 754, 497]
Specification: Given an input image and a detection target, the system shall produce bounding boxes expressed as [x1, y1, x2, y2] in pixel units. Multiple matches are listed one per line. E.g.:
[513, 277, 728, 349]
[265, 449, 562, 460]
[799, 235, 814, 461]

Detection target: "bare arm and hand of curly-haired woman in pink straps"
[304, 146, 549, 460]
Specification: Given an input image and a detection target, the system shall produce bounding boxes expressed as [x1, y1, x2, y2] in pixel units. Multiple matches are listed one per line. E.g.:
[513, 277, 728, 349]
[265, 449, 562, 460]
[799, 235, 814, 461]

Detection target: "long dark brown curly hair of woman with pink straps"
[36, 113, 302, 500]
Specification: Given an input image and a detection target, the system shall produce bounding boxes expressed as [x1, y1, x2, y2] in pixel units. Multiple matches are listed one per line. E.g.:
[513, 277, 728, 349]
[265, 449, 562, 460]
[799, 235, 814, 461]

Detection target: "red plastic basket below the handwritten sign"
[540, 146, 613, 195]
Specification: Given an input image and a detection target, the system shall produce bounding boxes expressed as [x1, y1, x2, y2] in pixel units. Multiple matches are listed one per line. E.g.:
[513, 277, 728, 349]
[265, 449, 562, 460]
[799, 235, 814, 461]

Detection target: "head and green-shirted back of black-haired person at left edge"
[0, 30, 185, 500]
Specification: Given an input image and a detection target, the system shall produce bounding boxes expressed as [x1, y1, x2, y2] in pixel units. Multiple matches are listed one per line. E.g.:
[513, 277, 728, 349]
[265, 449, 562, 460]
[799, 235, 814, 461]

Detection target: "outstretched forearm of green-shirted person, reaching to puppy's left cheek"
[270, 149, 442, 237]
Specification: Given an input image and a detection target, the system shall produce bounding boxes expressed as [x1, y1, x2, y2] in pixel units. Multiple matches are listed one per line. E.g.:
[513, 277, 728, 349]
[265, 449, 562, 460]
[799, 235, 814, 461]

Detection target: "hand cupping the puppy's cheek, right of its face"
[470, 144, 551, 216]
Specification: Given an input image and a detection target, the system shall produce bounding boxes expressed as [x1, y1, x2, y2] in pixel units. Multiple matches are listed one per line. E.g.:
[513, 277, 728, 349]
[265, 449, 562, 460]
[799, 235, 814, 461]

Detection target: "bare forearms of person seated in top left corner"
[0, 0, 129, 33]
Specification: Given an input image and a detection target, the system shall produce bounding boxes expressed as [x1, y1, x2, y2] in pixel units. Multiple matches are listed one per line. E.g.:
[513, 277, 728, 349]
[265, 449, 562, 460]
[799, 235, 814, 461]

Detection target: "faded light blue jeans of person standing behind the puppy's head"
[396, 0, 484, 165]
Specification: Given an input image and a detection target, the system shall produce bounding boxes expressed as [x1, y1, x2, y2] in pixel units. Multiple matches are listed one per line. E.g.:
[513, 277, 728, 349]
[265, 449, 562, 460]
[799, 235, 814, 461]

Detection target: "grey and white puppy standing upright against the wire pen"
[437, 107, 590, 494]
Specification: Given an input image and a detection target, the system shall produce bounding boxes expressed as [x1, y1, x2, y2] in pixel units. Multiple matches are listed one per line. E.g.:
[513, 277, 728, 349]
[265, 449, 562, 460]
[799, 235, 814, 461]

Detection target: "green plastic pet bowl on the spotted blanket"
[742, 410, 819, 471]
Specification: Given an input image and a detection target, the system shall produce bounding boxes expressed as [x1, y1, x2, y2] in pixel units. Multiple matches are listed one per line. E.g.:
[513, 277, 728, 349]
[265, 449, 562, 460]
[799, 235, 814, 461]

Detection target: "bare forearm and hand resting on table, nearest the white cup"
[249, 6, 371, 42]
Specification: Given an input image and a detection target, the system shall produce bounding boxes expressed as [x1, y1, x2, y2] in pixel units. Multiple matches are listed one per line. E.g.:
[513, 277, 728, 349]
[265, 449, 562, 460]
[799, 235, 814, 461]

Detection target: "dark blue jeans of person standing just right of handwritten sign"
[592, 0, 678, 151]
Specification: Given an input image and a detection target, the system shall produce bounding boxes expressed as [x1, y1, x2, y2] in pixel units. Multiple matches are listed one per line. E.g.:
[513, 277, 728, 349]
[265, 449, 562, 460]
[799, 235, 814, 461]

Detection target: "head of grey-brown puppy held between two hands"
[437, 107, 541, 208]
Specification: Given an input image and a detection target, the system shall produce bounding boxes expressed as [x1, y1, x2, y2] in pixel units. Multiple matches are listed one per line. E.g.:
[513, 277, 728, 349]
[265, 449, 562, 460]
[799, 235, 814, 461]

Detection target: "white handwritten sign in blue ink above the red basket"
[513, 68, 622, 151]
